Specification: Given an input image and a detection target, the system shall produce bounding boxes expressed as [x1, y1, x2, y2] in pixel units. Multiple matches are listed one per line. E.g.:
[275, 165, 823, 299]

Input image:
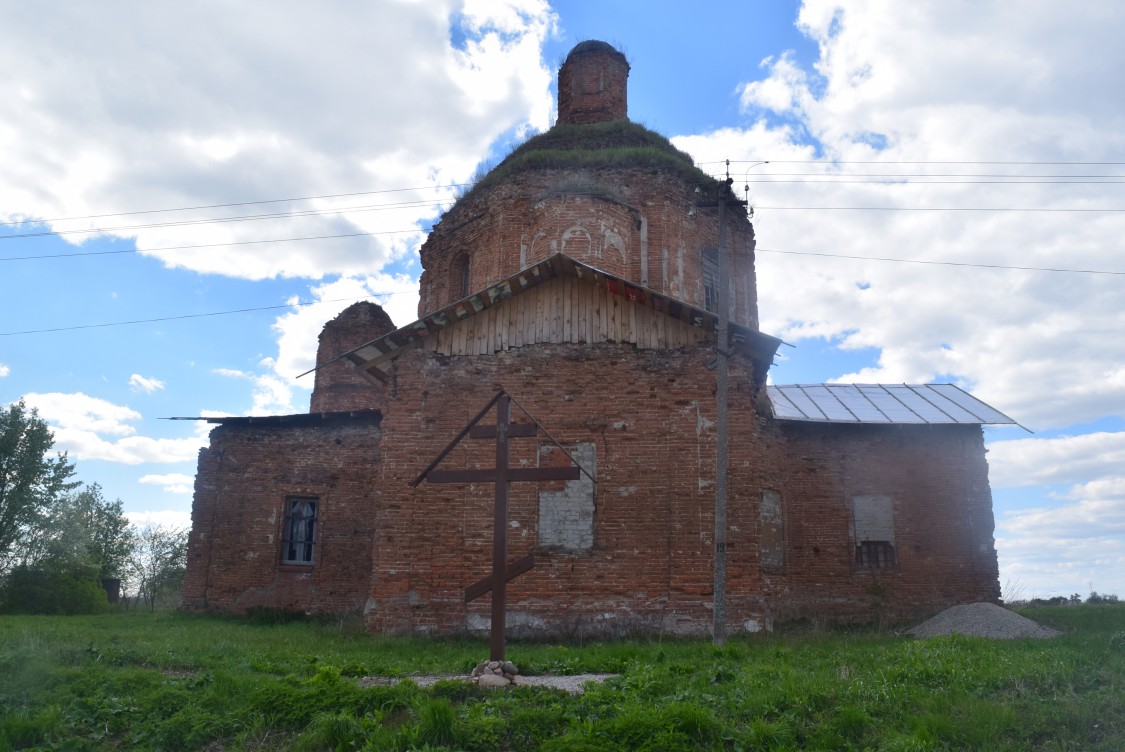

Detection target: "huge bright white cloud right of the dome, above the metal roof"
[675, 0, 1125, 430]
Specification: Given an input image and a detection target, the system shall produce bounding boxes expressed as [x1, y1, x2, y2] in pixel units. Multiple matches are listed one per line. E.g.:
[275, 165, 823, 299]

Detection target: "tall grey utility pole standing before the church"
[700, 160, 746, 645]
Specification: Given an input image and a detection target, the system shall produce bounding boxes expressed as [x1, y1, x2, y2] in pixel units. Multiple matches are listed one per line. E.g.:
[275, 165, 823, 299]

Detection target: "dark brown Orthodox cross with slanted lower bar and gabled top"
[411, 390, 584, 661]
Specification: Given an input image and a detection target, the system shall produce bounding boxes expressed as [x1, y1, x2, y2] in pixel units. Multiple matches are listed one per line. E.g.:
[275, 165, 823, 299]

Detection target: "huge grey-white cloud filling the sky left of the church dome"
[0, 0, 554, 279]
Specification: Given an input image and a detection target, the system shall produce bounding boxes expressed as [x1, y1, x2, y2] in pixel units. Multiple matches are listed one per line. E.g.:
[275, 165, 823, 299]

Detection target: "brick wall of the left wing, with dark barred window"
[183, 414, 379, 612]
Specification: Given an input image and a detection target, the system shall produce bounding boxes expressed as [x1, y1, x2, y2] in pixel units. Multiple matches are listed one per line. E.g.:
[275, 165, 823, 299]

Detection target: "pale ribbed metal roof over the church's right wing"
[767, 384, 1016, 424]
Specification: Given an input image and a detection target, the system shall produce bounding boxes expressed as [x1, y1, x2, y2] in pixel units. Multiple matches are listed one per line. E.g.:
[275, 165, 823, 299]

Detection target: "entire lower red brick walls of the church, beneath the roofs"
[185, 343, 999, 635]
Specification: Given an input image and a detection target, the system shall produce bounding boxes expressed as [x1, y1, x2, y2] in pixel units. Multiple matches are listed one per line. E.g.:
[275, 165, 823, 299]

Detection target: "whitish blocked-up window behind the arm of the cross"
[539, 444, 597, 552]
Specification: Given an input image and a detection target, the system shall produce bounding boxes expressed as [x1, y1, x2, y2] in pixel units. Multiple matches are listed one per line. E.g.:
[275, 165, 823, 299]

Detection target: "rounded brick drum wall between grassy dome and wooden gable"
[419, 168, 758, 329]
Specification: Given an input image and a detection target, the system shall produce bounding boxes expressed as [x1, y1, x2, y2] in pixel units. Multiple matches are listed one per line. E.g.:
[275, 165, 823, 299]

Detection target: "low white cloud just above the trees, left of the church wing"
[24, 392, 209, 465]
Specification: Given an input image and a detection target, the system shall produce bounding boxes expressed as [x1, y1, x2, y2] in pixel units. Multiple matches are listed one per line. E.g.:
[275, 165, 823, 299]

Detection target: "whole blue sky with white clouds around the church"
[0, 0, 1125, 599]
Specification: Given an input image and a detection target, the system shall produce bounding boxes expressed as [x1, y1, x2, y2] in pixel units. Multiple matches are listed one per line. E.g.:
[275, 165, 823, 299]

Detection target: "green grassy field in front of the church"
[0, 605, 1125, 752]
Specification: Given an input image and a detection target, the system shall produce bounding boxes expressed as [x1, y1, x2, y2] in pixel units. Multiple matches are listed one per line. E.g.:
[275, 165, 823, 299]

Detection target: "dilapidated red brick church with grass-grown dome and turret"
[183, 42, 1013, 636]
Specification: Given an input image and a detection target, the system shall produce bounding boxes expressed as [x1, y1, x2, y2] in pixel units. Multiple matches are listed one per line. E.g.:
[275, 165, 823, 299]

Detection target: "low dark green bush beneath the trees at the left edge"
[0, 566, 110, 615]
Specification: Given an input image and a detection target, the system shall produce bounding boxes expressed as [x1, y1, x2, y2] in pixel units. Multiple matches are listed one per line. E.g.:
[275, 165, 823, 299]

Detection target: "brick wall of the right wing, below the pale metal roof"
[762, 422, 999, 620]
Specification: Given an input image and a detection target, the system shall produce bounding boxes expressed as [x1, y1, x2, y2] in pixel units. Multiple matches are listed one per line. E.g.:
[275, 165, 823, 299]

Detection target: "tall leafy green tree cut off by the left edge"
[0, 400, 78, 574]
